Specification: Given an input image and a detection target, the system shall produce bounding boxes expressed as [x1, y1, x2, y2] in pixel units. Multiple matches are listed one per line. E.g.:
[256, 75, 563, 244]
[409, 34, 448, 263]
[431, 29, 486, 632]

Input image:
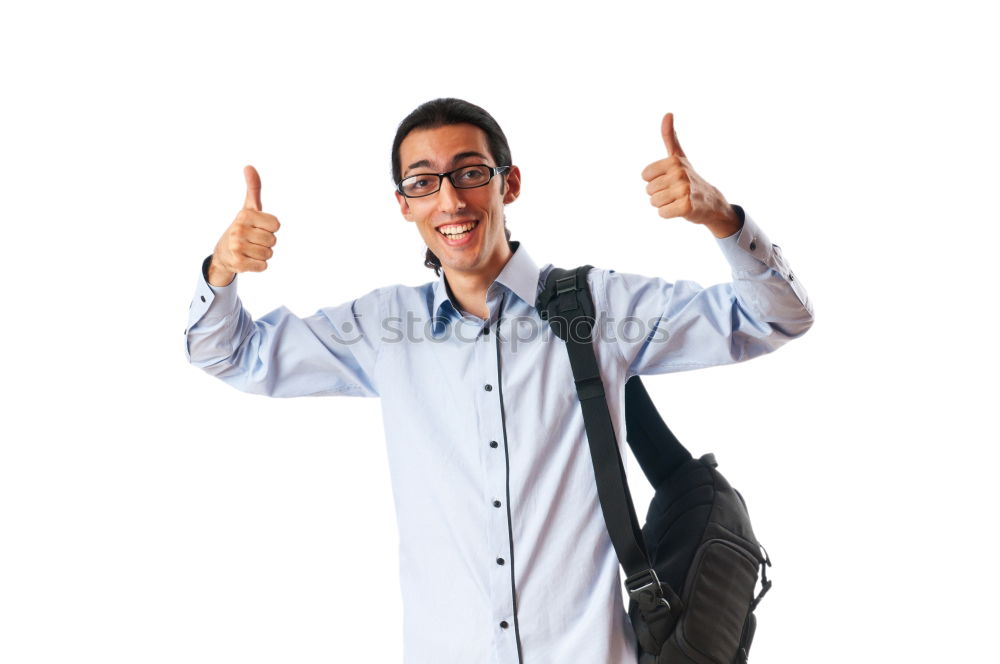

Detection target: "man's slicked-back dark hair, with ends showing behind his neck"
[392, 97, 511, 276]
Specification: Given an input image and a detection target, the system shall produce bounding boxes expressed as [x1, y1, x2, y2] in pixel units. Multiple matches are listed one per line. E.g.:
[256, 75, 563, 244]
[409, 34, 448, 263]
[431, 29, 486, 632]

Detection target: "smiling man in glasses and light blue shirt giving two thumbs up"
[186, 99, 812, 664]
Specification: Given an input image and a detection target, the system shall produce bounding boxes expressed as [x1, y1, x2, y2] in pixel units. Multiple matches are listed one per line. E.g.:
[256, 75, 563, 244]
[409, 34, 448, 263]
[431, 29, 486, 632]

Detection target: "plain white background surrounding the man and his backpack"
[0, 2, 1000, 664]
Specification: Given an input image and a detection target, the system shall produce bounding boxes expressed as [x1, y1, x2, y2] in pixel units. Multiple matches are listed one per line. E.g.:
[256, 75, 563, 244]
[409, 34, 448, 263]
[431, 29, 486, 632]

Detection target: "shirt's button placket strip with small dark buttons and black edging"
[475, 288, 520, 664]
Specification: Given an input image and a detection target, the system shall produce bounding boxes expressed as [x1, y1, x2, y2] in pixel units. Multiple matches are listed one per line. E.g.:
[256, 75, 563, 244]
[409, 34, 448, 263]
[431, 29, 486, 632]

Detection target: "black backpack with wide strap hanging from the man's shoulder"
[537, 265, 771, 664]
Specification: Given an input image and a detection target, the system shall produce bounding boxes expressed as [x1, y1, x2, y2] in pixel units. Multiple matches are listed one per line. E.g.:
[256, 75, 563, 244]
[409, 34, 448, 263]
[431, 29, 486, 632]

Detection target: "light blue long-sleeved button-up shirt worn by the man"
[185, 208, 813, 664]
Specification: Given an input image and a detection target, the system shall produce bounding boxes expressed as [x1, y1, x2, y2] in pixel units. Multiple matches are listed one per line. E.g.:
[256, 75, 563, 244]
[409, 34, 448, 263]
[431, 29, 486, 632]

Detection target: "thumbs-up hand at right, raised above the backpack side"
[642, 113, 742, 237]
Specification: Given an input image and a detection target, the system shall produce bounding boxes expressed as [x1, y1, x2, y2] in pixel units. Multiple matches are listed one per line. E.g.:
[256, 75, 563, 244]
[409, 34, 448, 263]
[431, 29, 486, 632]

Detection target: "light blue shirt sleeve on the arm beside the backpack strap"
[594, 205, 813, 379]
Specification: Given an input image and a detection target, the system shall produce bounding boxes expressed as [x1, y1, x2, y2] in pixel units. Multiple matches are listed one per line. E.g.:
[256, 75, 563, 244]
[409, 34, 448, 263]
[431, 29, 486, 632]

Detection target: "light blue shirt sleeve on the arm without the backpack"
[184, 256, 382, 397]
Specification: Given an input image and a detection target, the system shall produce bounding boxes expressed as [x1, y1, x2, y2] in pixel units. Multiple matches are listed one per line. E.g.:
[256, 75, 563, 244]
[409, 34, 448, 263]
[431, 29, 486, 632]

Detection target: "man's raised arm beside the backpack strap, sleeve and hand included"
[595, 113, 813, 376]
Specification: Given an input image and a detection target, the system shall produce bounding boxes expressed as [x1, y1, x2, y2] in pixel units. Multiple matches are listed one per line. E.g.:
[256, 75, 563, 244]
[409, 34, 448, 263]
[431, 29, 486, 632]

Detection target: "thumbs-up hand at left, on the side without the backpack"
[208, 166, 281, 286]
